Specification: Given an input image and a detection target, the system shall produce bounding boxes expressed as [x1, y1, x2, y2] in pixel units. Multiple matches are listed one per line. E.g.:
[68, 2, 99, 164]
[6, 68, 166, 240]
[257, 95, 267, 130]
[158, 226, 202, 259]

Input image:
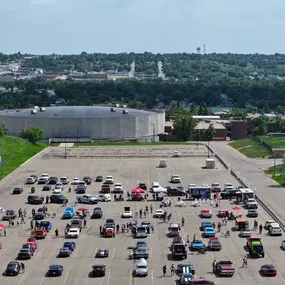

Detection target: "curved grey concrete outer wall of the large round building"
[0, 110, 165, 140]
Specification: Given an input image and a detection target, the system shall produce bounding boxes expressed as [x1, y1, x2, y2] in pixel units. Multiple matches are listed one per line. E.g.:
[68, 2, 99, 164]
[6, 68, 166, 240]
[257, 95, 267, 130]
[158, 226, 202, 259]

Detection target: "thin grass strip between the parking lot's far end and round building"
[74, 142, 197, 147]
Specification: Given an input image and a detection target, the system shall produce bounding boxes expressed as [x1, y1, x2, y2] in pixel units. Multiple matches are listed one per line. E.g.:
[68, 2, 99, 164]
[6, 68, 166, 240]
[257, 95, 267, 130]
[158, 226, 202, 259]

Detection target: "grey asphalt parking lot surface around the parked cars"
[0, 147, 285, 285]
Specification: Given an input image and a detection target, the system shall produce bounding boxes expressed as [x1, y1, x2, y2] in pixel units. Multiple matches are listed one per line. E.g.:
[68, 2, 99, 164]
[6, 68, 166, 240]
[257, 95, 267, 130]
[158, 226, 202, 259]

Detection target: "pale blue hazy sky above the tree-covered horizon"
[0, 0, 285, 54]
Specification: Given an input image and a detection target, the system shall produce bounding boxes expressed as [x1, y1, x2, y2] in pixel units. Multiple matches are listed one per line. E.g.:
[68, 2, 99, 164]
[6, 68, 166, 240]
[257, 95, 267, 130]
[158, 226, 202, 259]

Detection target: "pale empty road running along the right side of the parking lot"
[210, 142, 285, 222]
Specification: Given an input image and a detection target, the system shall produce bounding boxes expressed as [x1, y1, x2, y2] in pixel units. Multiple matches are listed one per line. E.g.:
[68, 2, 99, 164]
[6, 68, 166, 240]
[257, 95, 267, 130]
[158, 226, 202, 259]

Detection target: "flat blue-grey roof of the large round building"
[0, 106, 160, 118]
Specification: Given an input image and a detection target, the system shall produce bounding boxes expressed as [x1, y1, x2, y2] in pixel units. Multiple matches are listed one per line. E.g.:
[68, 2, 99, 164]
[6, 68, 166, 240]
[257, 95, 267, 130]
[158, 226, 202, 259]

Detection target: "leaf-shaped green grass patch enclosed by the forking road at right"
[227, 139, 271, 158]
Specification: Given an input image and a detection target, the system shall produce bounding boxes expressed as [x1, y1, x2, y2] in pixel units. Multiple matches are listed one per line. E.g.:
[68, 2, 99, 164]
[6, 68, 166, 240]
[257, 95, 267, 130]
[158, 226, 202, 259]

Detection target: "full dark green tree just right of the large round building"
[173, 115, 196, 141]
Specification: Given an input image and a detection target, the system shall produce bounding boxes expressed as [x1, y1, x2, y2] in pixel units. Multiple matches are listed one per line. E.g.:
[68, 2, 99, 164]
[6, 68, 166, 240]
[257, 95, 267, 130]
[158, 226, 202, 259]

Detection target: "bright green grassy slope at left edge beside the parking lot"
[0, 136, 48, 179]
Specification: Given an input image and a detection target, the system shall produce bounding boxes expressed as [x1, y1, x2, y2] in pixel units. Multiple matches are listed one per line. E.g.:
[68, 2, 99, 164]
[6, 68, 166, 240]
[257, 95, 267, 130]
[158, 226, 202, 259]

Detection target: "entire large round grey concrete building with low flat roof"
[0, 106, 165, 140]
